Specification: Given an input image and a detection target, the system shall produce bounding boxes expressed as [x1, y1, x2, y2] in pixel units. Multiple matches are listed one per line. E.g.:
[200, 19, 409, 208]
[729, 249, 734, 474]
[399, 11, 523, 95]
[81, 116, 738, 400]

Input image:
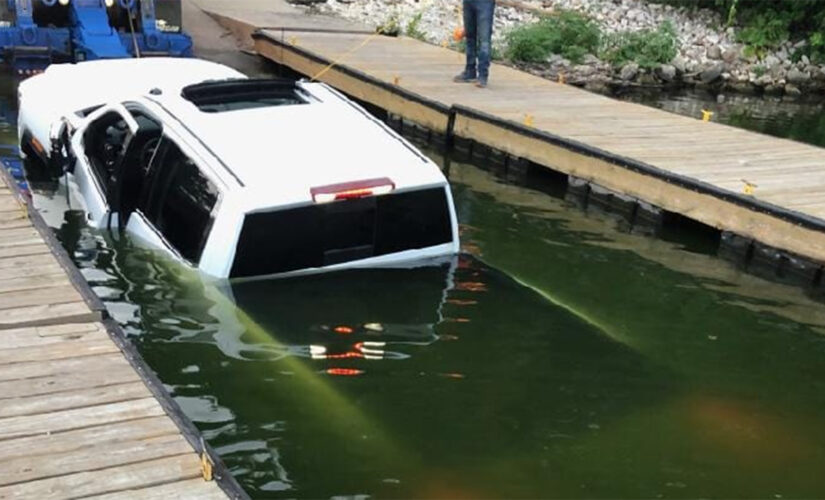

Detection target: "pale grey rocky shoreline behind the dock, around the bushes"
[308, 0, 825, 96]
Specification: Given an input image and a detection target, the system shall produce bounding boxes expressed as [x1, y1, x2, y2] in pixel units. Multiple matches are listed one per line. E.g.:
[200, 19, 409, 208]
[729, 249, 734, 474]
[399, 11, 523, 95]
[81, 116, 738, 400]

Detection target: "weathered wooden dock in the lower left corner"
[0, 171, 246, 500]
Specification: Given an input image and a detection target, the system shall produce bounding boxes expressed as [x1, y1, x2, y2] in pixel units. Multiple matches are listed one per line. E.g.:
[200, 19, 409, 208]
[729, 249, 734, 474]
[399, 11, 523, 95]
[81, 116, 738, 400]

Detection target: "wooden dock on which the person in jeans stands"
[197, 0, 825, 278]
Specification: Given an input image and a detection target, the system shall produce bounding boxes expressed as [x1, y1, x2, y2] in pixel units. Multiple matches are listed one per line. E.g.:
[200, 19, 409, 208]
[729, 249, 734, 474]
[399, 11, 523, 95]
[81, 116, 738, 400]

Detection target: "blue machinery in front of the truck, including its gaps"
[0, 0, 192, 74]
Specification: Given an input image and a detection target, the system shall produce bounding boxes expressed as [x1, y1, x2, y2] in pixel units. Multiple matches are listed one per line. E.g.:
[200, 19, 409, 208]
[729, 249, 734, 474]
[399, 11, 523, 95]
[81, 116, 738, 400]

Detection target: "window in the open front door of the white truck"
[83, 112, 130, 197]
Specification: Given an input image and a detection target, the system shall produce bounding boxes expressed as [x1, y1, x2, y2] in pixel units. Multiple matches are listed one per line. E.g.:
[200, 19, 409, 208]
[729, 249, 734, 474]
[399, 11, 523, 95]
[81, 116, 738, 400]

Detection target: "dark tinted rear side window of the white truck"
[141, 137, 218, 263]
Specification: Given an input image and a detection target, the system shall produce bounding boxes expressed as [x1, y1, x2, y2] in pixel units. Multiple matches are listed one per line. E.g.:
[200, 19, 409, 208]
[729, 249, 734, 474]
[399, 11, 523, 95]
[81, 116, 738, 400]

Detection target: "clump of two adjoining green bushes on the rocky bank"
[504, 11, 677, 68]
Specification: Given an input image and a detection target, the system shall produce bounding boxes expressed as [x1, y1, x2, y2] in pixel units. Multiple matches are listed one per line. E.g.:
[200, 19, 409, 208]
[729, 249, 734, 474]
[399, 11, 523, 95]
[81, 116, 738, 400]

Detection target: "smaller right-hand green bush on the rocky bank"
[601, 21, 677, 68]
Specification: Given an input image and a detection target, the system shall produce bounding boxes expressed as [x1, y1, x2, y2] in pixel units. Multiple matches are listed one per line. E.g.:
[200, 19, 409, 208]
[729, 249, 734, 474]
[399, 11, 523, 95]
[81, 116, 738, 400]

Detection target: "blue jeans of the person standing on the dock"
[463, 0, 496, 81]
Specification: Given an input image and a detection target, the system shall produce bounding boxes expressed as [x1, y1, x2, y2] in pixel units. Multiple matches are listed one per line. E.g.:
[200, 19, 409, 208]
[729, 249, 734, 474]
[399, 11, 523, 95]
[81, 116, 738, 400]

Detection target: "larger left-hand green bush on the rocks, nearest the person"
[504, 11, 601, 63]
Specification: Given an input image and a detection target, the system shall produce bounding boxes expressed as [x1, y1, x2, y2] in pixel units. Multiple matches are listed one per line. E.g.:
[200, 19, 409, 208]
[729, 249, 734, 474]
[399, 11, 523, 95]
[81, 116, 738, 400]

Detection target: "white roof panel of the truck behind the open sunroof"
[150, 81, 446, 207]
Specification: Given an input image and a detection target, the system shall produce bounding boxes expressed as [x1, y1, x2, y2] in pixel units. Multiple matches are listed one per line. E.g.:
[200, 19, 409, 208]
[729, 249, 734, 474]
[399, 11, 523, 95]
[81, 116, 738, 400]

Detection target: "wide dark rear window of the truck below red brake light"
[230, 187, 452, 277]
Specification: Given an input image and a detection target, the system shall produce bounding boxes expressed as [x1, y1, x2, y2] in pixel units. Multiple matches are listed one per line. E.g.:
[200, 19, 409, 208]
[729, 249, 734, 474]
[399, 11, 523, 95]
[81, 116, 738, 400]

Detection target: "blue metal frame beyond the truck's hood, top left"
[0, 0, 192, 73]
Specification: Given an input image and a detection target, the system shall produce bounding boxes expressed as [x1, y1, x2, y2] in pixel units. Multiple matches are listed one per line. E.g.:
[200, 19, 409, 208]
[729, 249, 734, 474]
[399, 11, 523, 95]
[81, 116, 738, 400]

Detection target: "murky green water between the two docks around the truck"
[2, 72, 825, 498]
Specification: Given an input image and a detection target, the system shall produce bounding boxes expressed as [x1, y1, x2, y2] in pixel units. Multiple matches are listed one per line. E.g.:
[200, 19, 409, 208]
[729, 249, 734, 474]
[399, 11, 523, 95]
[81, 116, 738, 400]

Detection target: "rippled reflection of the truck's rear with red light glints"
[204, 266, 457, 368]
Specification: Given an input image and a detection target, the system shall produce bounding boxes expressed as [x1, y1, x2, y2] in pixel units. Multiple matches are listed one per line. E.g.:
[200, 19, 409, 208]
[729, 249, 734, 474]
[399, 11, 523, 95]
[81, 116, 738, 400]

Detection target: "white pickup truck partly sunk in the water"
[18, 58, 458, 278]
